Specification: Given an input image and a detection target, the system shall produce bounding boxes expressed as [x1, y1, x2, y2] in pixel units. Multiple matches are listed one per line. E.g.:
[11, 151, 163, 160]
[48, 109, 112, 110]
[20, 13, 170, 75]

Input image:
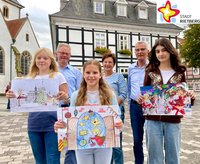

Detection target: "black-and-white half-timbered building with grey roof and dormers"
[49, 0, 183, 75]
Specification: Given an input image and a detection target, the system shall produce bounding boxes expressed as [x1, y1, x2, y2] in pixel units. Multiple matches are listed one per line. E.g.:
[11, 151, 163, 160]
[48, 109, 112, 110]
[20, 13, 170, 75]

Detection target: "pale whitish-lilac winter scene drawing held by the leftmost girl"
[10, 79, 59, 112]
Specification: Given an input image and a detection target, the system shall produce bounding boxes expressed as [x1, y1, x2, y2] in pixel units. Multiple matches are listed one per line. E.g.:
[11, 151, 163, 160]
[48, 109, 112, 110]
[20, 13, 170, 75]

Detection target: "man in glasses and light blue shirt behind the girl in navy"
[55, 43, 82, 164]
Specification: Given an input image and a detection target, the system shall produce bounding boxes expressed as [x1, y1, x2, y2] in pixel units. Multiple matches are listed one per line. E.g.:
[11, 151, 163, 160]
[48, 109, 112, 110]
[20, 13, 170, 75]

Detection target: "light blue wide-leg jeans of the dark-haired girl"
[145, 120, 181, 164]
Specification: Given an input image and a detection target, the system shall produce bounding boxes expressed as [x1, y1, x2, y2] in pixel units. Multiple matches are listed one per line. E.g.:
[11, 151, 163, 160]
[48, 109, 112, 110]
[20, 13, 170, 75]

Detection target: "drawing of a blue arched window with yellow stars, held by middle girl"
[57, 105, 120, 151]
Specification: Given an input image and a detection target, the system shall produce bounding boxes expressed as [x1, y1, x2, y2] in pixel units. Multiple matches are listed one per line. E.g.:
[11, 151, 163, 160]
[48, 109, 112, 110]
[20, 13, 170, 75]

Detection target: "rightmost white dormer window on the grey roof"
[136, 1, 149, 19]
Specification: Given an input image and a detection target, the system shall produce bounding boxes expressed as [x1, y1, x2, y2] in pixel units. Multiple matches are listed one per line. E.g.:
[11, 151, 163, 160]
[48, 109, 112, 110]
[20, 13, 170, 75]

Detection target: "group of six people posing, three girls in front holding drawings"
[6, 38, 195, 164]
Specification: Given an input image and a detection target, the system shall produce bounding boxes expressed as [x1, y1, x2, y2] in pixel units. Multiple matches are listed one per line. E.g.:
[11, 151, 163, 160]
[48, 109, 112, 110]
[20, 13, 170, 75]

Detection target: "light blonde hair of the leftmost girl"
[28, 48, 58, 78]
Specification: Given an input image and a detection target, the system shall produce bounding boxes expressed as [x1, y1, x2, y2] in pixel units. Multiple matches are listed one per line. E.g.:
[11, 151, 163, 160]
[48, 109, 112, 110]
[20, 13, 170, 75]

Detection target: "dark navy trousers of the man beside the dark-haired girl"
[130, 100, 144, 164]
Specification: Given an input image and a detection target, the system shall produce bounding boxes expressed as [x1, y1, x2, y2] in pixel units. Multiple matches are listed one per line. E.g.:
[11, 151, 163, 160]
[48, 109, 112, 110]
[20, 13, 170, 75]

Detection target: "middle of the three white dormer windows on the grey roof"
[115, 0, 128, 17]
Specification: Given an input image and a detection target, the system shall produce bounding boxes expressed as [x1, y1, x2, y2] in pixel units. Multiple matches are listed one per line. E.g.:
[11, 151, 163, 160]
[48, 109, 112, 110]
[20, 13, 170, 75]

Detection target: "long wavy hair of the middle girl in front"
[75, 60, 113, 106]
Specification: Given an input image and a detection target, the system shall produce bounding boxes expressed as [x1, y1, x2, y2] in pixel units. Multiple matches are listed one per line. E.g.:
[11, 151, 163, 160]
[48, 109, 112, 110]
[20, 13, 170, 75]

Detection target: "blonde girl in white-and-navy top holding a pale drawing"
[6, 48, 68, 164]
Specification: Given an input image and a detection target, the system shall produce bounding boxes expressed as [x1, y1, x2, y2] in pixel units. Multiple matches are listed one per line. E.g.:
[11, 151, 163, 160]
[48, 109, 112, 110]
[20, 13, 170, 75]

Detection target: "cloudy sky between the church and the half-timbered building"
[18, 0, 60, 48]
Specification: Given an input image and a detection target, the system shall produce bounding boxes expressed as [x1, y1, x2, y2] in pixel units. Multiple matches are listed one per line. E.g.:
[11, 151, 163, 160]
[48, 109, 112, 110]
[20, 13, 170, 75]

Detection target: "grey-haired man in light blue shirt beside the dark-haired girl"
[128, 41, 149, 164]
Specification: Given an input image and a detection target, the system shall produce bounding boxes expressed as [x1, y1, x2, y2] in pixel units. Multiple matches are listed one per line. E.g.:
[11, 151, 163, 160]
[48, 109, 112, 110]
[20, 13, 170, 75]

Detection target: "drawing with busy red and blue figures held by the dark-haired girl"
[141, 83, 191, 115]
